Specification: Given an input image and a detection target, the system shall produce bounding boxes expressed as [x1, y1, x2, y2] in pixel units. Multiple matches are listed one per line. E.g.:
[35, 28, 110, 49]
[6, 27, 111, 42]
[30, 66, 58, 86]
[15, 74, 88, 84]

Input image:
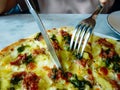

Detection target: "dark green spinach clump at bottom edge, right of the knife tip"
[69, 74, 92, 90]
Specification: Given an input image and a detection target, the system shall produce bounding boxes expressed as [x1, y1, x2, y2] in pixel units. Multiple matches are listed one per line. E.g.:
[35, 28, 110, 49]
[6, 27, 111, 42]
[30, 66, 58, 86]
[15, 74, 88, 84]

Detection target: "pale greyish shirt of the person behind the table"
[38, 0, 114, 13]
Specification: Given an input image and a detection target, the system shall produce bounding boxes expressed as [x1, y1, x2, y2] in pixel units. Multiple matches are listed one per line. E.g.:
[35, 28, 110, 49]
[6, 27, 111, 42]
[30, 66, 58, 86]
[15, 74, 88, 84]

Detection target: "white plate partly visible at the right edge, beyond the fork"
[107, 11, 120, 35]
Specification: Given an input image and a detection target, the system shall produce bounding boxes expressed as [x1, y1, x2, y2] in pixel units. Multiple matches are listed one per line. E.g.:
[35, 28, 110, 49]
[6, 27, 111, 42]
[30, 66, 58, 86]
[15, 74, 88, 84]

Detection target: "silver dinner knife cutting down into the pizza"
[25, 0, 62, 69]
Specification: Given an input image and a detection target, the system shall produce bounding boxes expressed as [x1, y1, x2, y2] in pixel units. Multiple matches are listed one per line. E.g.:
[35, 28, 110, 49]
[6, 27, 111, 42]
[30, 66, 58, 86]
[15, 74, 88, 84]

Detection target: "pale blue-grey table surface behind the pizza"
[0, 14, 120, 49]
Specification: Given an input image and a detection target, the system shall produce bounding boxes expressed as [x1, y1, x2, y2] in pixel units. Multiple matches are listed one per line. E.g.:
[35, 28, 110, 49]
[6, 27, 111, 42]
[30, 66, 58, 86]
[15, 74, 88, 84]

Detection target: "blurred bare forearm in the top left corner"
[0, 0, 17, 14]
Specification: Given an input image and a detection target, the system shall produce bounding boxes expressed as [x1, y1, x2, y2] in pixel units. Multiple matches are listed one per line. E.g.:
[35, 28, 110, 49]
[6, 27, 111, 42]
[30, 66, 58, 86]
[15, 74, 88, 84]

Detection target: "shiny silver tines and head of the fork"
[70, 24, 93, 57]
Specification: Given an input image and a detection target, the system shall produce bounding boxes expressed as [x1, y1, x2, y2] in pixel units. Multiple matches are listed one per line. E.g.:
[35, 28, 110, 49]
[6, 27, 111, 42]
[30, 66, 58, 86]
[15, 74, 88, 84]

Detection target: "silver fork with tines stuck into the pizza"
[70, 4, 103, 57]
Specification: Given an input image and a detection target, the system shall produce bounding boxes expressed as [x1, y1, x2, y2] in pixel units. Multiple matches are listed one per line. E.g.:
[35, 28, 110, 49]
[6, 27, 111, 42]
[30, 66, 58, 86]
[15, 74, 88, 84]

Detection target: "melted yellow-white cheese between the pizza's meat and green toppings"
[0, 27, 120, 90]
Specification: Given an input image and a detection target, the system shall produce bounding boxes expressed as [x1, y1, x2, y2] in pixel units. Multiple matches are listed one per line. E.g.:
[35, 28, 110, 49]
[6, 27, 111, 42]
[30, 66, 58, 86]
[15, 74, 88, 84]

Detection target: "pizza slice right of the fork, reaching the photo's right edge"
[92, 36, 120, 90]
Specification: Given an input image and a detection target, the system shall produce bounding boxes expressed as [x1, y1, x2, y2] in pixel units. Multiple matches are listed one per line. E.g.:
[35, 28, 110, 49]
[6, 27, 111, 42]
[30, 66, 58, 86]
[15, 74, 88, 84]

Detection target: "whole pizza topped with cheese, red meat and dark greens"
[0, 27, 120, 90]
